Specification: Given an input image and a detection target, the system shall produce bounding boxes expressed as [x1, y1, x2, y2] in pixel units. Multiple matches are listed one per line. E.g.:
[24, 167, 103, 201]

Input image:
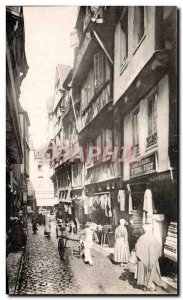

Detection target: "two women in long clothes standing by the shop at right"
[114, 219, 162, 291]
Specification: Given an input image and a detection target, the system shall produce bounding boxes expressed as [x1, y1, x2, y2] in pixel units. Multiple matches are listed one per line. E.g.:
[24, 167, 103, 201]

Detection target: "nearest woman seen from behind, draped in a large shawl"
[135, 224, 162, 291]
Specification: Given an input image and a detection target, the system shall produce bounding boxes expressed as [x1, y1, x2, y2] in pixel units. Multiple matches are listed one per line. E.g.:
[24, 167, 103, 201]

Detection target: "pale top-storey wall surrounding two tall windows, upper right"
[114, 6, 155, 103]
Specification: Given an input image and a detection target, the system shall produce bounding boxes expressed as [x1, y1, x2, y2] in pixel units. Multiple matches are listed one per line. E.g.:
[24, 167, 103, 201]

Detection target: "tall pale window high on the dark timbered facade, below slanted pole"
[94, 51, 104, 88]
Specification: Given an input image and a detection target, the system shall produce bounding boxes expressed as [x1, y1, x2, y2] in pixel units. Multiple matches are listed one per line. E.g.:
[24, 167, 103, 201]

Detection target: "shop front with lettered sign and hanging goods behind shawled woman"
[125, 152, 178, 275]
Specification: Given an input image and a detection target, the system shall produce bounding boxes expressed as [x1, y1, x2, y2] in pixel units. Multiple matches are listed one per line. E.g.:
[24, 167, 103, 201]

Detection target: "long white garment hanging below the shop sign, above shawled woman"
[143, 189, 153, 223]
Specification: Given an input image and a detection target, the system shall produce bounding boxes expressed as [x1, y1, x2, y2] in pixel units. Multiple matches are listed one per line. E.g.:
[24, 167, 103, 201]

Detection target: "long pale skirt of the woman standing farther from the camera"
[114, 237, 130, 263]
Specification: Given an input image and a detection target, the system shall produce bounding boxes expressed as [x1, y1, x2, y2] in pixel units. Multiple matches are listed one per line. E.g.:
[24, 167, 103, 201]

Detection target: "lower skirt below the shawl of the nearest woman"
[137, 260, 161, 288]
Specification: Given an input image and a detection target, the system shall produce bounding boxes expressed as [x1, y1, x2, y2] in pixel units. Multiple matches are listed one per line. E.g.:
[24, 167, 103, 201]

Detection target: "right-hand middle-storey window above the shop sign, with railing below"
[148, 92, 157, 136]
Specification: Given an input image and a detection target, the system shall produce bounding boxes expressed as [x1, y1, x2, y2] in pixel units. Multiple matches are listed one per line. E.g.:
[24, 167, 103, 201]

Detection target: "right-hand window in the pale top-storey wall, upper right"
[134, 6, 145, 47]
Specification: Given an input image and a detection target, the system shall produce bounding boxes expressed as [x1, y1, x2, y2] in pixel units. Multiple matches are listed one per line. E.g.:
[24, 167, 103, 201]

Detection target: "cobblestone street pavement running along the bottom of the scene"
[16, 223, 166, 294]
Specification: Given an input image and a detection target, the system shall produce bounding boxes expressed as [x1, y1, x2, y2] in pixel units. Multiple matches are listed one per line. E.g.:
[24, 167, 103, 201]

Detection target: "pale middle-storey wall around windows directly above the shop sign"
[124, 75, 169, 180]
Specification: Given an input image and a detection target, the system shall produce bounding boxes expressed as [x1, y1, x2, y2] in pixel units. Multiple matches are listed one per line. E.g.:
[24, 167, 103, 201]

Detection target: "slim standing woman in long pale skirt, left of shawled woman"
[114, 219, 130, 266]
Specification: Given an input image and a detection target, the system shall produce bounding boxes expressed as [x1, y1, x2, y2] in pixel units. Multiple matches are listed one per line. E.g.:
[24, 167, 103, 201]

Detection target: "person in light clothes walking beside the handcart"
[80, 223, 98, 266]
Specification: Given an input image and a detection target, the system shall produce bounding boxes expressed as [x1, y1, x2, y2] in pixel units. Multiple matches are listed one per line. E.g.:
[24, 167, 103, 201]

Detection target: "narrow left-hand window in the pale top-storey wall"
[120, 9, 128, 65]
